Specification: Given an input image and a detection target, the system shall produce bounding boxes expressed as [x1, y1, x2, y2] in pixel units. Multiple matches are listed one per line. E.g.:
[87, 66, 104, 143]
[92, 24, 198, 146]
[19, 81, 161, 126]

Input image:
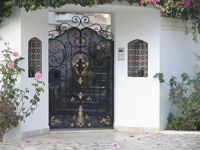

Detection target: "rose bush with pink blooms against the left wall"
[0, 43, 44, 142]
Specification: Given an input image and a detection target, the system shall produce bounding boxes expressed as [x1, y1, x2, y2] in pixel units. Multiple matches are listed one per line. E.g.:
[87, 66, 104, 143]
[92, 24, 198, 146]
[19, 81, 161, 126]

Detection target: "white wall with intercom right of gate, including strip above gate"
[50, 3, 160, 131]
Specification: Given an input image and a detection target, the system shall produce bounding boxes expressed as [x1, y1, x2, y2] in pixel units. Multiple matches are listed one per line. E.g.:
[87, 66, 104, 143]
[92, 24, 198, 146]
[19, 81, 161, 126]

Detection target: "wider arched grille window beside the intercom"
[128, 40, 148, 77]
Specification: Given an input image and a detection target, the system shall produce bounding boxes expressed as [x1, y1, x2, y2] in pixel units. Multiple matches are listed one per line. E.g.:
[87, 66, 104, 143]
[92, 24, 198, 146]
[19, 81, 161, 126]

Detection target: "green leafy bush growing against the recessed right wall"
[154, 72, 200, 130]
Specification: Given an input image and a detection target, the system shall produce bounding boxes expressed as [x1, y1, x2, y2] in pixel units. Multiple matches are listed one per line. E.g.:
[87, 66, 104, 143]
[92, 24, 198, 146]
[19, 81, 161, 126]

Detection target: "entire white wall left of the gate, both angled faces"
[0, 9, 49, 141]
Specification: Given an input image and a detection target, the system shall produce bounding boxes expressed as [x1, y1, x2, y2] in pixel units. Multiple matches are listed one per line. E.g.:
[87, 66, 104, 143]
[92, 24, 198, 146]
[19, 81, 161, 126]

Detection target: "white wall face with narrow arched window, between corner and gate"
[21, 10, 49, 136]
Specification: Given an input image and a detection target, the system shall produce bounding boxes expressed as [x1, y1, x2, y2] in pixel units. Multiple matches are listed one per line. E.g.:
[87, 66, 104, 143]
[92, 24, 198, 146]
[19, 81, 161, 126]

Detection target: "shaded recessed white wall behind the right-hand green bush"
[160, 18, 200, 129]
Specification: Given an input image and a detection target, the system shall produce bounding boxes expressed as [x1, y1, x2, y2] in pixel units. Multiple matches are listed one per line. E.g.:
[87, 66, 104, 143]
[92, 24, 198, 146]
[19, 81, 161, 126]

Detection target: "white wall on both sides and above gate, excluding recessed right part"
[0, 3, 160, 141]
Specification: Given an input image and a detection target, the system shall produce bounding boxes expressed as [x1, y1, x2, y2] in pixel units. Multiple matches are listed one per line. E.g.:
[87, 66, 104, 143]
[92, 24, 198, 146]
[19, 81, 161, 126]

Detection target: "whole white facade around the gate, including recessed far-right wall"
[0, 3, 200, 140]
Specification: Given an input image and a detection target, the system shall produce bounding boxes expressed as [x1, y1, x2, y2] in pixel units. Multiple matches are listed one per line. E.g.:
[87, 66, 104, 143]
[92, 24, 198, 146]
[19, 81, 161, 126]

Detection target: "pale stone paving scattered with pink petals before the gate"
[0, 131, 200, 150]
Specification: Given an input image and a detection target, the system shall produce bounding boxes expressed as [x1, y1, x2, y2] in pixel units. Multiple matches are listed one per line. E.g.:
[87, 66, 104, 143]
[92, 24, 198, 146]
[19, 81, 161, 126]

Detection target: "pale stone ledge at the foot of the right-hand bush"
[160, 130, 200, 135]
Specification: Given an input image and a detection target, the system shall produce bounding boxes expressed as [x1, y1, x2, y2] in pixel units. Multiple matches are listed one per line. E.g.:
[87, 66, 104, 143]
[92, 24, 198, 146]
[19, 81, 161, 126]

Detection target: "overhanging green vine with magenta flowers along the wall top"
[0, 0, 200, 41]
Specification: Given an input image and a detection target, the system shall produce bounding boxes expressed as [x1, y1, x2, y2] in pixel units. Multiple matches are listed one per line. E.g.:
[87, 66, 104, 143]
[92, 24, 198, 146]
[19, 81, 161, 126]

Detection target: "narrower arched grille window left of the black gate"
[28, 37, 42, 78]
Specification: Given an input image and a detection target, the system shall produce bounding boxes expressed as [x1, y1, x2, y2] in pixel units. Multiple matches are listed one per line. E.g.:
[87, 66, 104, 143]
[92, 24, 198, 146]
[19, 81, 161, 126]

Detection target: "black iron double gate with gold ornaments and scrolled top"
[49, 16, 114, 128]
